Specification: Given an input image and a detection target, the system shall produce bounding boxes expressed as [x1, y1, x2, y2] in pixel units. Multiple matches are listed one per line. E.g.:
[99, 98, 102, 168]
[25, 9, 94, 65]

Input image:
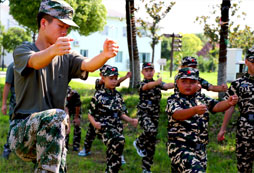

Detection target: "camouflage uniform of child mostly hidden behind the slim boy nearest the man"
[84, 64, 111, 153]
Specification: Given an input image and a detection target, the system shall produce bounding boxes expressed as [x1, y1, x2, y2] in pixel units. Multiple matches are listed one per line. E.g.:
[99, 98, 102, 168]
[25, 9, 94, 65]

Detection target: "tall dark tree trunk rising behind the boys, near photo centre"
[126, 0, 140, 88]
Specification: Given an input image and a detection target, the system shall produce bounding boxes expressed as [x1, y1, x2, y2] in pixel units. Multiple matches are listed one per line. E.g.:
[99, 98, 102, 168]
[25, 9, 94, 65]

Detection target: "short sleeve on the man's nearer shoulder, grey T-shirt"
[13, 43, 35, 76]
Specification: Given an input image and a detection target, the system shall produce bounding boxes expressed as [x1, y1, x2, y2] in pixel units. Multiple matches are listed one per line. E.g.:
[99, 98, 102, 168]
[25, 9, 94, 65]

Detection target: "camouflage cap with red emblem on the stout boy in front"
[176, 67, 199, 80]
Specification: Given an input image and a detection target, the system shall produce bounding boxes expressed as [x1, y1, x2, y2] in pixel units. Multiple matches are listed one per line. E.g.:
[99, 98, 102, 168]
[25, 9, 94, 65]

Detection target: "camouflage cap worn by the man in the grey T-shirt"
[39, 0, 79, 27]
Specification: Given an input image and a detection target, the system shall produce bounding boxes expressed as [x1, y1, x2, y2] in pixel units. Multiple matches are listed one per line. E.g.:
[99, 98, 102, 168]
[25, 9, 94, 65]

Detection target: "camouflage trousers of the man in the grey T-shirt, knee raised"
[9, 109, 68, 173]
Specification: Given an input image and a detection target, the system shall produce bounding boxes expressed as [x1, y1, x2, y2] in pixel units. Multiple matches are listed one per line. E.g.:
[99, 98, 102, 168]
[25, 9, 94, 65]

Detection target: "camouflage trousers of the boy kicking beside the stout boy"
[136, 109, 159, 171]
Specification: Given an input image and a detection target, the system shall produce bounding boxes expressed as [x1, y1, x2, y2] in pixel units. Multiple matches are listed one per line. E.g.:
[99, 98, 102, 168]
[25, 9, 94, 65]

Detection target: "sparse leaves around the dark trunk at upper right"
[196, 0, 254, 54]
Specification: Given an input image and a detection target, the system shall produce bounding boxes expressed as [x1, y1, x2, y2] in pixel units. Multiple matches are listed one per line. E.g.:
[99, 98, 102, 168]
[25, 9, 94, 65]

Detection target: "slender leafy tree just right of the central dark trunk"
[137, 0, 175, 63]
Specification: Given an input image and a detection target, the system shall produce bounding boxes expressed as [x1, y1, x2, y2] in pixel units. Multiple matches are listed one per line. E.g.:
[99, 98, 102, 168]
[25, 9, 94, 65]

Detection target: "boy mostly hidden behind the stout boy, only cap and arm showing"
[181, 56, 228, 92]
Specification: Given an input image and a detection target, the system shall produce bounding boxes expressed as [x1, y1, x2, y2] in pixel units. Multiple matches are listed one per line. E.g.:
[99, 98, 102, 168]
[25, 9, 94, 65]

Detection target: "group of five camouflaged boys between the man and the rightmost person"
[67, 57, 238, 173]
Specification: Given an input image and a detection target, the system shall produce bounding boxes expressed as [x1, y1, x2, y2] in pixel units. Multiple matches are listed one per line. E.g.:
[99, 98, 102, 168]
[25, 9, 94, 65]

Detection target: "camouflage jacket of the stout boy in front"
[165, 93, 218, 144]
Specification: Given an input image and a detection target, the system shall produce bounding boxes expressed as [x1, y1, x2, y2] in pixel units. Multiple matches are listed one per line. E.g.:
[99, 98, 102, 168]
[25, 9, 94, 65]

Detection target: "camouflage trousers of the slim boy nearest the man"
[96, 127, 125, 173]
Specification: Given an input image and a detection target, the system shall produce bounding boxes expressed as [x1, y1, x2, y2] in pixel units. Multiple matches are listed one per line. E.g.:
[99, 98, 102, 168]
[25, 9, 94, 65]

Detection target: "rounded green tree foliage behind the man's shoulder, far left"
[3, 27, 31, 52]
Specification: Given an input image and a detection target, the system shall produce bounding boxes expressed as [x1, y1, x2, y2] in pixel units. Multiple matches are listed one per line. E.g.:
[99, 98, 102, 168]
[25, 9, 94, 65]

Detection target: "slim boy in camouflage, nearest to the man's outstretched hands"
[88, 67, 138, 172]
